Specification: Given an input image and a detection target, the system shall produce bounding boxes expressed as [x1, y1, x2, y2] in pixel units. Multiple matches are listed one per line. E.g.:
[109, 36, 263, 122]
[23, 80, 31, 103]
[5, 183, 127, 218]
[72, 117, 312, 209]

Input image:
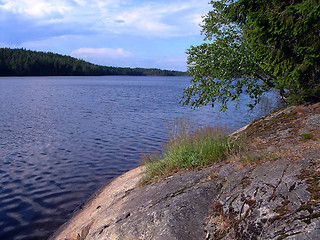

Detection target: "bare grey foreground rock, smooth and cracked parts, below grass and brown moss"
[53, 159, 320, 240]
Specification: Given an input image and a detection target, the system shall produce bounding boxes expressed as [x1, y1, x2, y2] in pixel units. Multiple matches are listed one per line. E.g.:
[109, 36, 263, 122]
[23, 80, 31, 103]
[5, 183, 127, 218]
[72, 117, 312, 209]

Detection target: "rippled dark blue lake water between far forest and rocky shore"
[0, 76, 280, 240]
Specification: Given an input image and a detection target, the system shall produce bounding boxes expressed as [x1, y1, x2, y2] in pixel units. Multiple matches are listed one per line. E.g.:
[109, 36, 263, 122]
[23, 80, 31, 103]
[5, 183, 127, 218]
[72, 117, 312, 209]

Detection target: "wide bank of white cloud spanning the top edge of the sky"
[0, 0, 208, 38]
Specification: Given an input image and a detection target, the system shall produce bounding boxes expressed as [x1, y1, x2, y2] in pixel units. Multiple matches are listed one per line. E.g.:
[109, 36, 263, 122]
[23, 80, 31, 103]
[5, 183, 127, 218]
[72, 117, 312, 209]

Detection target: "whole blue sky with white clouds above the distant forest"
[0, 0, 211, 71]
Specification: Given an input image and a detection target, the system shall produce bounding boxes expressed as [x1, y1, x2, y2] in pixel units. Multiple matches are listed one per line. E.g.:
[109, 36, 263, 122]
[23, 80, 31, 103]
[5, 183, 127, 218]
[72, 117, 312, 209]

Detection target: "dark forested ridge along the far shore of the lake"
[0, 48, 186, 76]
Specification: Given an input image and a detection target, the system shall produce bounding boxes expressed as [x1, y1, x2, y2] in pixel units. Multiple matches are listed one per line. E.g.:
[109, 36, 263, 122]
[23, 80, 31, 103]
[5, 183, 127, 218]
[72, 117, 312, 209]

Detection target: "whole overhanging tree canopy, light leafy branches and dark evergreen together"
[181, 0, 320, 110]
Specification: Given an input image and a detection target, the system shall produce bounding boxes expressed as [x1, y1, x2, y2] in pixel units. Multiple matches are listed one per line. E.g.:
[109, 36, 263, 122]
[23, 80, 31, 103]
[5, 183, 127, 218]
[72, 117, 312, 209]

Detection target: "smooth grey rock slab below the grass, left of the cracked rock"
[93, 169, 220, 239]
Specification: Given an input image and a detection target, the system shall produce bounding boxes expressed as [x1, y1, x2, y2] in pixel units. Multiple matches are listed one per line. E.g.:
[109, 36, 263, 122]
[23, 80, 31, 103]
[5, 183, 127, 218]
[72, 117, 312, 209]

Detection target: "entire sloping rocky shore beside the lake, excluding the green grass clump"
[50, 104, 320, 240]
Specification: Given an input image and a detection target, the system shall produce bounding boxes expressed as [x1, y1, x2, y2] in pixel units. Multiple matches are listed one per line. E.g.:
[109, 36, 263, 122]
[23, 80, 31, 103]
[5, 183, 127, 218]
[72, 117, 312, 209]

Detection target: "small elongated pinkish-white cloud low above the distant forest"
[70, 48, 131, 59]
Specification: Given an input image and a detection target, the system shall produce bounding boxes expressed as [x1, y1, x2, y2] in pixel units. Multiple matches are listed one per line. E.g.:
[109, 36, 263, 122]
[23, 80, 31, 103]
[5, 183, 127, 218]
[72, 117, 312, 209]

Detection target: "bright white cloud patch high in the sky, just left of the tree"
[97, 0, 208, 38]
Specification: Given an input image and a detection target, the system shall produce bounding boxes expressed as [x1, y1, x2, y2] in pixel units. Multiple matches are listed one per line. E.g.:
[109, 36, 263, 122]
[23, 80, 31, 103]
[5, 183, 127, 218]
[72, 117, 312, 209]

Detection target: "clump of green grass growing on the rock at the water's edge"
[142, 127, 242, 183]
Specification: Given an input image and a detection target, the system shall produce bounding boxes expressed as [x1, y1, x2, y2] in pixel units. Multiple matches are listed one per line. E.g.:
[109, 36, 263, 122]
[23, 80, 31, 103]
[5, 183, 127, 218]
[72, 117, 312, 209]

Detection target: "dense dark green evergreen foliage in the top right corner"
[229, 0, 320, 102]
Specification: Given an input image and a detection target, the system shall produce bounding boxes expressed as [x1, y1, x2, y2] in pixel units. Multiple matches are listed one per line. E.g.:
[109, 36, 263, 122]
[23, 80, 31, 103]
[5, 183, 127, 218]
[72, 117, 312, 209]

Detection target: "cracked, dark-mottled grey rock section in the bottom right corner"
[206, 159, 320, 239]
